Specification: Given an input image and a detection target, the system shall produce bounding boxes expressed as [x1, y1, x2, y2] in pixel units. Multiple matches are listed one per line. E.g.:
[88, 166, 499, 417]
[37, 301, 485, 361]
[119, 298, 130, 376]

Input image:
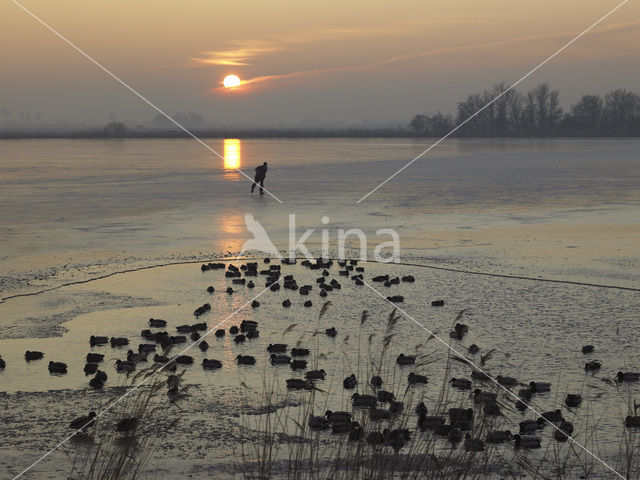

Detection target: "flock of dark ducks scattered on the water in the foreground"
[0, 258, 640, 452]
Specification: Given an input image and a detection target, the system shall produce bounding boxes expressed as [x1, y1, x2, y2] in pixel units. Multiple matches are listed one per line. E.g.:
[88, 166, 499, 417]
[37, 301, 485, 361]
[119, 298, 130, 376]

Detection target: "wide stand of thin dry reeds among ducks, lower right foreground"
[237, 308, 640, 480]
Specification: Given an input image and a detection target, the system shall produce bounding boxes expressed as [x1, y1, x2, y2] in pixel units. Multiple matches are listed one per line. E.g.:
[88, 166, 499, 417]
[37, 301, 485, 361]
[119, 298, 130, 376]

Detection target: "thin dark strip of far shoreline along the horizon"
[0, 128, 640, 140]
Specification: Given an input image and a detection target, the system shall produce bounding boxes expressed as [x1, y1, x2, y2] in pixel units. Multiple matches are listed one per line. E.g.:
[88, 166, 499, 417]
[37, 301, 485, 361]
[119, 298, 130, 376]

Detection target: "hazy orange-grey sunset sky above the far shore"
[0, 0, 640, 127]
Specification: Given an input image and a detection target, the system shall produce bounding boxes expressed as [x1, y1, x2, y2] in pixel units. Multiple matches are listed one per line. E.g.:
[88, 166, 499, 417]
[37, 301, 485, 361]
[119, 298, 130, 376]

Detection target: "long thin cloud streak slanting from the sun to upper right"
[212, 20, 640, 92]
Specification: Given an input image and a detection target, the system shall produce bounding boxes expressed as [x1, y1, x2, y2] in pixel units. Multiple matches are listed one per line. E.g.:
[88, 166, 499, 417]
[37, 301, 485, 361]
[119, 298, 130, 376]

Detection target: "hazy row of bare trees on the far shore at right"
[409, 83, 640, 136]
